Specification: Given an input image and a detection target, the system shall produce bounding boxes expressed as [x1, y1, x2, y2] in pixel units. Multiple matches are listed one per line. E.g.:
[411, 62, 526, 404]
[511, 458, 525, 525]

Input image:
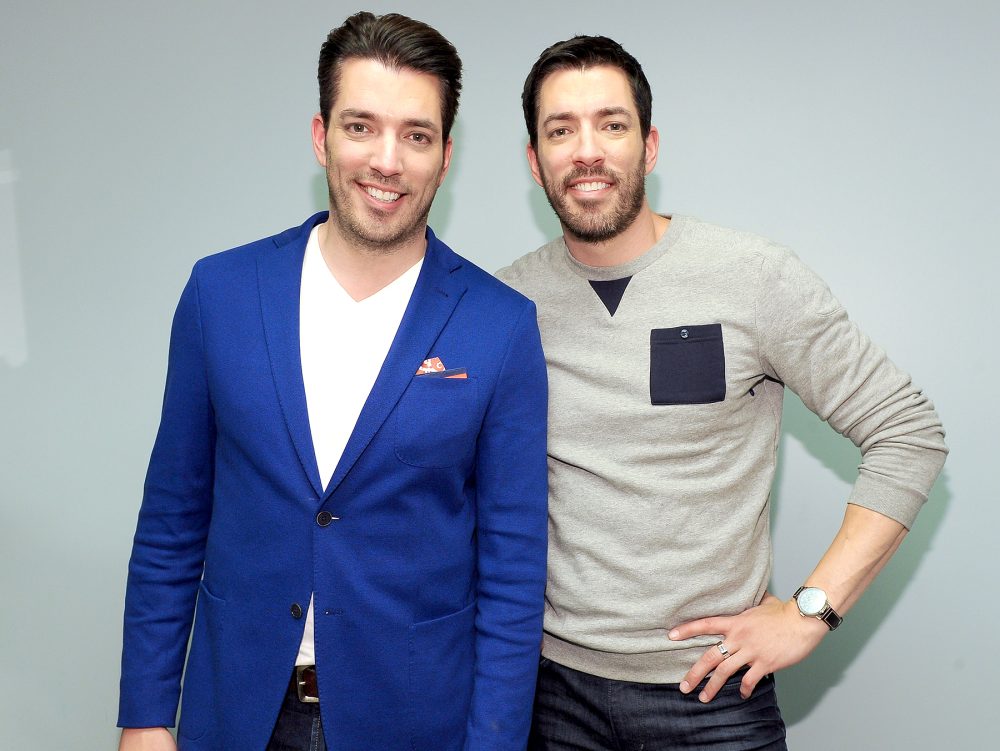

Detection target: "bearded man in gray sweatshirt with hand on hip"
[498, 37, 947, 751]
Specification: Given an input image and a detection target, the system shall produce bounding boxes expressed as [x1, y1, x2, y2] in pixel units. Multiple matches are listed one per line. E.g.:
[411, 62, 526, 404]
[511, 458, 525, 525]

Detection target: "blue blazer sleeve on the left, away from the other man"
[118, 267, 215, 727]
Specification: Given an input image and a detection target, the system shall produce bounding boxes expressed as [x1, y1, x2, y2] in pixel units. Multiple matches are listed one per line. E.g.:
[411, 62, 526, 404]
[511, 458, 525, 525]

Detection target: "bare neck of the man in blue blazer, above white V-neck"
[317, 220, 427, 301]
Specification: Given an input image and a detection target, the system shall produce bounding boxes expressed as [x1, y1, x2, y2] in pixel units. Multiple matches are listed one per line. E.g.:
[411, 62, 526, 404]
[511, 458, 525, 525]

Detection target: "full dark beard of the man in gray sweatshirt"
[538, 158, 646, 243]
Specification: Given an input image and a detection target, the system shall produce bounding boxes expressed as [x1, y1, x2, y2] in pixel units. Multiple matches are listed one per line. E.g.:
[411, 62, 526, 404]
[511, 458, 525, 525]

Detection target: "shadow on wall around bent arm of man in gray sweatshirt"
[772, 398, 951, 726]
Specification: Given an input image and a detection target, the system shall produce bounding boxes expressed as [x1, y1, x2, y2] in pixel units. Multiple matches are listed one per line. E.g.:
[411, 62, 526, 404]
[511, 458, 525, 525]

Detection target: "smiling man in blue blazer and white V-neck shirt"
[118, 13, 546, 751]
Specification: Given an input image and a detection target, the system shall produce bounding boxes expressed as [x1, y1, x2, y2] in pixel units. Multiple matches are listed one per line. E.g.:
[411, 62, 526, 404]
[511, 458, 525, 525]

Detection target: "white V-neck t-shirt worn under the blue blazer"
[295, 225, 423, 665]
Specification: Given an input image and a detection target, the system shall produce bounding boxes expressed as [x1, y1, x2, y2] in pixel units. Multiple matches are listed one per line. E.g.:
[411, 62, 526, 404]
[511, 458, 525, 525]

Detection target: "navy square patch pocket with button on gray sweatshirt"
[649, 323, 726, 404]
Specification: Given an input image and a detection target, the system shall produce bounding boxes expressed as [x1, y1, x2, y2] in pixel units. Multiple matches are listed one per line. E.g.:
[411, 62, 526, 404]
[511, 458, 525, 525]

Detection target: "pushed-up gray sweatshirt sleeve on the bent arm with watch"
[757, 249, 948, 528]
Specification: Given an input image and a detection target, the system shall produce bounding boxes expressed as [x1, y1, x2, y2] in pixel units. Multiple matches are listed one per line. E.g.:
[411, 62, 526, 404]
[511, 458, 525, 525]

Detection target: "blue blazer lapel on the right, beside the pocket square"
[324, 227, 466, 498]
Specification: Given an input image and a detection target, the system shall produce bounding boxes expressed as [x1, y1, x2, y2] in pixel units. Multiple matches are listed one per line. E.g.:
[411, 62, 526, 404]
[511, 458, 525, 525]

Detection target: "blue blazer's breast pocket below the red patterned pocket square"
[396, 375, 480, 468]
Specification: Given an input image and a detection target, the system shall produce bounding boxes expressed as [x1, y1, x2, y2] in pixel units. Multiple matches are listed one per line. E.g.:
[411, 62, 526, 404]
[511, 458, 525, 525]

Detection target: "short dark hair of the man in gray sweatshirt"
[521, 35, 653, 148]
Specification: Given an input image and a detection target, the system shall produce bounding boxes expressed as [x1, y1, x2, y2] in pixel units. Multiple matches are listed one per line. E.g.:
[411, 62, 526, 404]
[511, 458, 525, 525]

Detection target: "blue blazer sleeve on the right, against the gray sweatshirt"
[465, 303, 548, 751]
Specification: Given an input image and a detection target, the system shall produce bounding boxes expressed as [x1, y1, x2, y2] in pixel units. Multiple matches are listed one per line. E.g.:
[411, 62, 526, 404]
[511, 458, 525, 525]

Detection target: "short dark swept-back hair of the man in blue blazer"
[318, 11, 462, 141]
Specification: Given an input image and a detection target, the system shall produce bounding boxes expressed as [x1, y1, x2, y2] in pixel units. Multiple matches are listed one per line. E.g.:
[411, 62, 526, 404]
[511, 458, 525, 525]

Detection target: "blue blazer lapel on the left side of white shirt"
[257, 213, 326, 497]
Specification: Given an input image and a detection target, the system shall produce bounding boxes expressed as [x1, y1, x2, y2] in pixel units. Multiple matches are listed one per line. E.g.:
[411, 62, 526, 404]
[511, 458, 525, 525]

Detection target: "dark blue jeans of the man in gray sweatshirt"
[528, 657, 787, 751]
